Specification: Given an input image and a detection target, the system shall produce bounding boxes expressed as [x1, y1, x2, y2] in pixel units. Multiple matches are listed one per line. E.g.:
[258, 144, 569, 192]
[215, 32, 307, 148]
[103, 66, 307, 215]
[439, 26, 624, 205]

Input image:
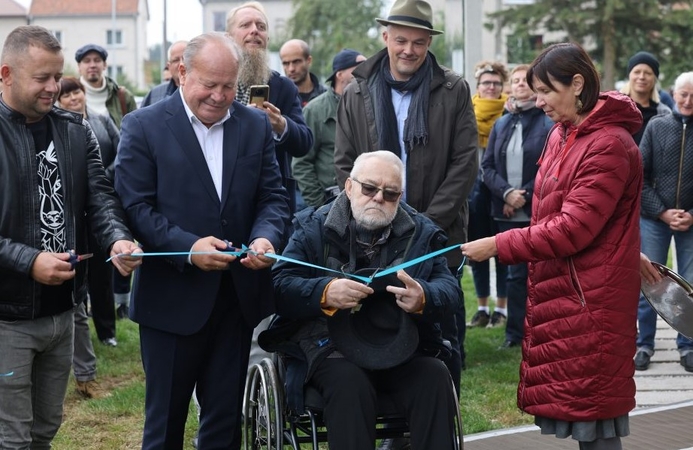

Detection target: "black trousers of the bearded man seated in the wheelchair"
[310, 356, 457, 450]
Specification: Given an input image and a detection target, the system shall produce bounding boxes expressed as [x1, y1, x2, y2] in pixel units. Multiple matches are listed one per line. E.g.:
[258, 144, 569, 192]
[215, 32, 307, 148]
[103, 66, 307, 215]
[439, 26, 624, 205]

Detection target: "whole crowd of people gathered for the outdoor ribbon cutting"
[0, 0, 693, 450]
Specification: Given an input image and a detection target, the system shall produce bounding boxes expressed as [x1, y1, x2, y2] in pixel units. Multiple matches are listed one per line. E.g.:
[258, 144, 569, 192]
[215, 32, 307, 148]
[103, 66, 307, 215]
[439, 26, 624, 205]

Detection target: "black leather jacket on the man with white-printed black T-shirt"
[0, 97, 132, 320]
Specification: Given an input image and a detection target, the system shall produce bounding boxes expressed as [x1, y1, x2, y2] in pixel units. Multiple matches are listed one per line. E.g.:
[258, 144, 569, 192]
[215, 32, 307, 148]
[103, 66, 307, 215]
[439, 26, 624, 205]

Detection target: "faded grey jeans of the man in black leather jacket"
[0, 309, 74, 450]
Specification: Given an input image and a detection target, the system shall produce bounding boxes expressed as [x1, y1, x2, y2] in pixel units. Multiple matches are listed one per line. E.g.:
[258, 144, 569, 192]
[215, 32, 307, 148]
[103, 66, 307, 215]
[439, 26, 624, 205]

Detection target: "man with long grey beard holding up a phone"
[226, 1, 313, 216]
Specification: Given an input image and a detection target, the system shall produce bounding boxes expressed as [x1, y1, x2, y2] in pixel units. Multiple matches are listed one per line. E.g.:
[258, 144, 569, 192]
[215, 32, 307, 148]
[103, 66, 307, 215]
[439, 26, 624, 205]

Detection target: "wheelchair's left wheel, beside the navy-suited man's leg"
[243, 358, 284, 450]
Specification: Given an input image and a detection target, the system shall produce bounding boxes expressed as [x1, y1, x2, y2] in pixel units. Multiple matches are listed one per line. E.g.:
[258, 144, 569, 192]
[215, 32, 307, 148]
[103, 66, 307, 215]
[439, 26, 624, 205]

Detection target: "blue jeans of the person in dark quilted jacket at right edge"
[637, 217, 693, 351]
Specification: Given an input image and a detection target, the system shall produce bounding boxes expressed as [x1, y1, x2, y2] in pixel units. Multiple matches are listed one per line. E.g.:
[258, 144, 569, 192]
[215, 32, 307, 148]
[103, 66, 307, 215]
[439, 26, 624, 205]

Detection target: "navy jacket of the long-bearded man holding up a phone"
[268, 71, 313, 213]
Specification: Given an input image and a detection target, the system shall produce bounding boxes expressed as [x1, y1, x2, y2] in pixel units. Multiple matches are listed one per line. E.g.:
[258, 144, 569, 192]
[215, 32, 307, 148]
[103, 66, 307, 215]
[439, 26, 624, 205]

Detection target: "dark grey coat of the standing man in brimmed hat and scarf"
[334, 49, 479, 267]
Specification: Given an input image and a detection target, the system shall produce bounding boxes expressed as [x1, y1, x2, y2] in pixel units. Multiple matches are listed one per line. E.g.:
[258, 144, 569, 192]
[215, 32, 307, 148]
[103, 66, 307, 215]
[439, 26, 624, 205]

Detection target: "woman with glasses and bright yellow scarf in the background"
[467, 61, 508, 334]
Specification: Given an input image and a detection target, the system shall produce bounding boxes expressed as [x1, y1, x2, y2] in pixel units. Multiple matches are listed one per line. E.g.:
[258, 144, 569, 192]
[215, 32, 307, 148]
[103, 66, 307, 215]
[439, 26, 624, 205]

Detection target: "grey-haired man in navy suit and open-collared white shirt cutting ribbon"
[115, 33, 289, 450]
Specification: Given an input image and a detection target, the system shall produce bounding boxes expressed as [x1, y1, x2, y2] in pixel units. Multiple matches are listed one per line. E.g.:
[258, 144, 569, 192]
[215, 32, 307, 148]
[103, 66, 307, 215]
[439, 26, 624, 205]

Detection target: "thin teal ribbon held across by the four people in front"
[106, 244, 467, 284]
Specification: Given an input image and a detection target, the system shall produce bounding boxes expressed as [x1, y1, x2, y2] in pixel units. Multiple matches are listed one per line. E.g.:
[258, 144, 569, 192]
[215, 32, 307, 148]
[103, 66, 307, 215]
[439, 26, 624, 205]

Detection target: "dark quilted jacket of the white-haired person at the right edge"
[640, 112, 693, 220]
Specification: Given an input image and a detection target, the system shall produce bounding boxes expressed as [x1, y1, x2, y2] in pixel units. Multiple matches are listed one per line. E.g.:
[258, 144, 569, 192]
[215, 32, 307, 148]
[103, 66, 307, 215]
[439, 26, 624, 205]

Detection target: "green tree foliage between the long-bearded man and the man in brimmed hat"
[287, 0, 383, 79]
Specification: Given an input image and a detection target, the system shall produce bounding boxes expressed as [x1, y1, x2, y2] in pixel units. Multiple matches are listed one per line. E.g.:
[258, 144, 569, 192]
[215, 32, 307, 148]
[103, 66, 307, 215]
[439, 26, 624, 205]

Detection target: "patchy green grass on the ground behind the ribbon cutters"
[53, 270, 533, 450]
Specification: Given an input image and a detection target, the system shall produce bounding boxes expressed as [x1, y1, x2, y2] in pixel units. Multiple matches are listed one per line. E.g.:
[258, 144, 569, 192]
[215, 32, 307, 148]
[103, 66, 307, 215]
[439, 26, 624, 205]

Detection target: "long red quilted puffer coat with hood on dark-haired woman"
[496, 93, 642, 421]
